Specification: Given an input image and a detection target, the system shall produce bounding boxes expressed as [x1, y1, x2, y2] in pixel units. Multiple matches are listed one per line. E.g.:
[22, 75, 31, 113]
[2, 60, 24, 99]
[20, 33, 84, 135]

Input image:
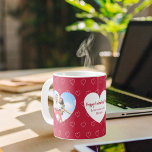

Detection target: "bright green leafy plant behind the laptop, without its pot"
[65, 0, 152, 56]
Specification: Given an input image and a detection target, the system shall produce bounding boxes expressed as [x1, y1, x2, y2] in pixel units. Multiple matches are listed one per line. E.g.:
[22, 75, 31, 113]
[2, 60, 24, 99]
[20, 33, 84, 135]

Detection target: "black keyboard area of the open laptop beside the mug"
[107, 89, 152, 109]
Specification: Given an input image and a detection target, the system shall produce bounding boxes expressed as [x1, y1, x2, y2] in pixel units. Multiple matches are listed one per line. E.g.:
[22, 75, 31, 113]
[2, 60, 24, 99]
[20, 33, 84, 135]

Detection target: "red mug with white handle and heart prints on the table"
[41, 71, 106, 139]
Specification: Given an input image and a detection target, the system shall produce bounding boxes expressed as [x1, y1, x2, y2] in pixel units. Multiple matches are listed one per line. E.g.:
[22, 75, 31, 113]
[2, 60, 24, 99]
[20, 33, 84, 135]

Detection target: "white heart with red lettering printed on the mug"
[84, 90, 106, 123]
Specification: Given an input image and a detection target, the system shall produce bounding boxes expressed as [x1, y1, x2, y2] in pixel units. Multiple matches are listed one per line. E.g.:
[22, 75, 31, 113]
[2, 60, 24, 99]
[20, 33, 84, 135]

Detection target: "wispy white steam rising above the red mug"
[76, 34, 94, 67]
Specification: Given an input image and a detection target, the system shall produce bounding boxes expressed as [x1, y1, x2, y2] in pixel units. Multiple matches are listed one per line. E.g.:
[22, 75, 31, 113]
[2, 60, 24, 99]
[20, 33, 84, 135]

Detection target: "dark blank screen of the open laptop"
[112, 21, 152, 99]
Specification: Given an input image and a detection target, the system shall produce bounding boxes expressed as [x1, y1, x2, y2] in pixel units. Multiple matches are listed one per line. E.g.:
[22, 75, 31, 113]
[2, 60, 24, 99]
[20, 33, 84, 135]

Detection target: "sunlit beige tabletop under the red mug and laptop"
[0, 69, 152, 152]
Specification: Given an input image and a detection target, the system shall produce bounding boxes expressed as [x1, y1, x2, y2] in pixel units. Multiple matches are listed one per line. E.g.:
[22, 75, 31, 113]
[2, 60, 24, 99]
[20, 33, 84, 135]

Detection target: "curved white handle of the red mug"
[41, 78, 53, 125]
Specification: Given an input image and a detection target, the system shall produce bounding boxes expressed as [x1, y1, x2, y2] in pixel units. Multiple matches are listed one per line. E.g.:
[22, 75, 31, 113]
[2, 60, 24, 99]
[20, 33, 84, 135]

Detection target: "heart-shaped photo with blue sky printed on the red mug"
[53, 90, 76, 123]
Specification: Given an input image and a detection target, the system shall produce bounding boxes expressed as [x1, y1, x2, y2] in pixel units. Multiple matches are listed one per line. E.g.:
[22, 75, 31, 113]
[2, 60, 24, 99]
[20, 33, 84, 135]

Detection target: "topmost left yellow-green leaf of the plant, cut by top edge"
[65, 0, 95, 13]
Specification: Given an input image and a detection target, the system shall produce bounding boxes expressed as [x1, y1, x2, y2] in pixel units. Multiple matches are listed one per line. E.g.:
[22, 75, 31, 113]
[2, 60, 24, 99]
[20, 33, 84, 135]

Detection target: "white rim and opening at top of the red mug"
[53, 71, 106, 78]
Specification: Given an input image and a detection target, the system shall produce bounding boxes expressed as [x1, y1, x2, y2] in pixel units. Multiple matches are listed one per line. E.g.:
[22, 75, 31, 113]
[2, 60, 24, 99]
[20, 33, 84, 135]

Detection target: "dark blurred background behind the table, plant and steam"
[0, 0, 152, 70]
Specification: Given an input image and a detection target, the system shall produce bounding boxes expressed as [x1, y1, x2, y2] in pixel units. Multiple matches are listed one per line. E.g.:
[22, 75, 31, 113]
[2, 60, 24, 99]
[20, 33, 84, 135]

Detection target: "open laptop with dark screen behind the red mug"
[106, 21, 152, 119]
